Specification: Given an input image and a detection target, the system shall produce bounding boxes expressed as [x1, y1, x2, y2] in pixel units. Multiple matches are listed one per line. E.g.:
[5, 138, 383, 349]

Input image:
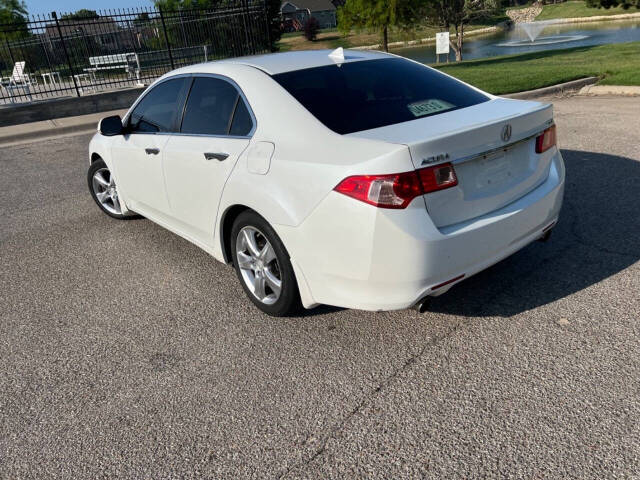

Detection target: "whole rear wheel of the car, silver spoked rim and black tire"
[231, 211, 301, 317]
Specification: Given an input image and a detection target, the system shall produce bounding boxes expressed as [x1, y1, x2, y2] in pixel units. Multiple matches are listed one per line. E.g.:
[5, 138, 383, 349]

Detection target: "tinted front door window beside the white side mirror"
[129, 78, 190, 132]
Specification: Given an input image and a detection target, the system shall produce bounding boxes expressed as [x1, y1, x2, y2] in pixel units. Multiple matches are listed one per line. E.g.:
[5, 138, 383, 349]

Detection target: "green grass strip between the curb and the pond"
[437, 42, 640, 94]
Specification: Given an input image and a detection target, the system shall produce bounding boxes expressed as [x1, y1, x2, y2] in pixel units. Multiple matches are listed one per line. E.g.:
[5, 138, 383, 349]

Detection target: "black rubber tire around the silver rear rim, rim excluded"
[230, 211, 302, 317]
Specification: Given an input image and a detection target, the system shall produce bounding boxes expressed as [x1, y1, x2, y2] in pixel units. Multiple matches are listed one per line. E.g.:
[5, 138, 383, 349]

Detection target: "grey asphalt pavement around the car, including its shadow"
[0, 97, 640, 479]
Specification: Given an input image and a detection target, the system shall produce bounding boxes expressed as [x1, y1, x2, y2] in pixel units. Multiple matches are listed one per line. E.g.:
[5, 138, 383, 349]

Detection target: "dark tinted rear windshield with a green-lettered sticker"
[273, 58, 489, 134]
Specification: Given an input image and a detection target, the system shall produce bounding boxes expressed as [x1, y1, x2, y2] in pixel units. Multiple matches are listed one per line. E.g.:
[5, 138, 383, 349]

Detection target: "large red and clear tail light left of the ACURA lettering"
[334, 163, 458, 208]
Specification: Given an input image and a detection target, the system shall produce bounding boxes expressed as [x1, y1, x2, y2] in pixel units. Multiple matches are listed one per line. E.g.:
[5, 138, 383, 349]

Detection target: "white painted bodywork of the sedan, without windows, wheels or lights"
[89, 51, 565, 310]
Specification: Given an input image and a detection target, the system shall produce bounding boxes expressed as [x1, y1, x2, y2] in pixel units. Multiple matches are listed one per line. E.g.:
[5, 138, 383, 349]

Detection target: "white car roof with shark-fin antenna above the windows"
[181, 49, 392, 75]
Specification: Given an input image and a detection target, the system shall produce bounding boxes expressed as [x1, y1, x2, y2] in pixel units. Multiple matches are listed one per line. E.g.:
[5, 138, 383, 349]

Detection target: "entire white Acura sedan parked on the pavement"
[88, 49, 565, 315]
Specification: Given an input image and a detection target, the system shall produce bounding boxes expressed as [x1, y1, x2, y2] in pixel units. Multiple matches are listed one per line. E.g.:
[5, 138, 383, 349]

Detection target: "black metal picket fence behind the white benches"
[0, 0, 271, 104]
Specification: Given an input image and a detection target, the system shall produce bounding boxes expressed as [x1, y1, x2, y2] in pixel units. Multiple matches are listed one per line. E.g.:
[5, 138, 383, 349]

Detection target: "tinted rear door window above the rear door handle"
[181, 77, 238, 135]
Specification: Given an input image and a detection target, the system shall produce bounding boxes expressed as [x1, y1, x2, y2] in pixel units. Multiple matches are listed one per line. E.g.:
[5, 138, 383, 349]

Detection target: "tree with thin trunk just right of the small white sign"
[428, 0, 500, 62]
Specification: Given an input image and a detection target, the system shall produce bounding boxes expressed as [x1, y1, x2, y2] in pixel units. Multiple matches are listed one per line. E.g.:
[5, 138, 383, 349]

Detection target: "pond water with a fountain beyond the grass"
[393, 18, 640, 63]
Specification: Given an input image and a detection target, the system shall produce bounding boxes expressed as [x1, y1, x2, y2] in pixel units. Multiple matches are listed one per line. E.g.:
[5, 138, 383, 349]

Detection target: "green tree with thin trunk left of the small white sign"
[338, 0, 424, 52]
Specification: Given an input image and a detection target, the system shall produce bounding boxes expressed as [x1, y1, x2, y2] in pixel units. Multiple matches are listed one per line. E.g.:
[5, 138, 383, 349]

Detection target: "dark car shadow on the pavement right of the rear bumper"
[429, 150, 640, 317]
